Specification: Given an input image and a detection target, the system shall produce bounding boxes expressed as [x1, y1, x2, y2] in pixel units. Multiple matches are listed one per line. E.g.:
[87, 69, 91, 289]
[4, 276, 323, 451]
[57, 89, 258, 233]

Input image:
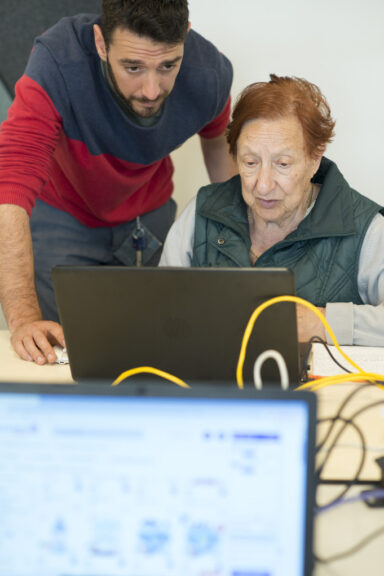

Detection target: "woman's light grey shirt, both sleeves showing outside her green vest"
[159, 197, 384, 346]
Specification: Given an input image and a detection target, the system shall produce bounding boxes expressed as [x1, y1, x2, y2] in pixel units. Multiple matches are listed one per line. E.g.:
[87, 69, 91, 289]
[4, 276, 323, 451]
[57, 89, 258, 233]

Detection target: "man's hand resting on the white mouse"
[11, 320, 65, 365]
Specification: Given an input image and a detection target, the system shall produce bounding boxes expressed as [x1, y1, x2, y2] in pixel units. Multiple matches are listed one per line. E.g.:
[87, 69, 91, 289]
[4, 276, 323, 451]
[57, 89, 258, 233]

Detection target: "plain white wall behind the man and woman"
[173, 0, 384, 214]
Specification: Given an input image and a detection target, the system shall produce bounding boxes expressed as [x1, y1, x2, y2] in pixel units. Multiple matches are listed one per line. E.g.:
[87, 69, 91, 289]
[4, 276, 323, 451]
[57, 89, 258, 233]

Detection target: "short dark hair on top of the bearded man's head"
[101, 0, 189, 49]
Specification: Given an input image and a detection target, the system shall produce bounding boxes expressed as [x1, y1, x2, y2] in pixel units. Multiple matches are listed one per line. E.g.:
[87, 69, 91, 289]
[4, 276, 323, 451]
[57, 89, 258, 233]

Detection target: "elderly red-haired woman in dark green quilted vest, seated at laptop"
[160, 75, 384, 346]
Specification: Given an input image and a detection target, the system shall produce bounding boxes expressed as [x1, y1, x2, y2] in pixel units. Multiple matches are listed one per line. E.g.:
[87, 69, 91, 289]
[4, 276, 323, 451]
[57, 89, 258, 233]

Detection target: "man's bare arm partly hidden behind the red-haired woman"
[200, 134, 237, 182]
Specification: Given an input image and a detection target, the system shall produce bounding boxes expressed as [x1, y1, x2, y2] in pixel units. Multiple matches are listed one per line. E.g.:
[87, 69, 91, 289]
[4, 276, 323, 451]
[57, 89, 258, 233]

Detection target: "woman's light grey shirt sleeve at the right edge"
[326, 214, 384, 346]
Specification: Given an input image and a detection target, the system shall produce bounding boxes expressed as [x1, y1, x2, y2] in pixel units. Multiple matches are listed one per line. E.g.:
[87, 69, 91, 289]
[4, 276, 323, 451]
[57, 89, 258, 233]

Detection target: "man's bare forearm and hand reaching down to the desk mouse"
[0, 204, 64, 364]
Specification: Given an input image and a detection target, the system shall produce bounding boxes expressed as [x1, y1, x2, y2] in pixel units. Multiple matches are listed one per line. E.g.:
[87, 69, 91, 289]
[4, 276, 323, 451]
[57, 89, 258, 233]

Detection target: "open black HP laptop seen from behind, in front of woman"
[52, 266, 299, 385]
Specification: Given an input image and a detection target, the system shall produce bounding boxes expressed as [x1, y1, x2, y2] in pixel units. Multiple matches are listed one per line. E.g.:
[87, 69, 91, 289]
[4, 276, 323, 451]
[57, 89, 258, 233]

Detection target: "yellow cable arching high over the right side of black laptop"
[236, 296, 364, 389]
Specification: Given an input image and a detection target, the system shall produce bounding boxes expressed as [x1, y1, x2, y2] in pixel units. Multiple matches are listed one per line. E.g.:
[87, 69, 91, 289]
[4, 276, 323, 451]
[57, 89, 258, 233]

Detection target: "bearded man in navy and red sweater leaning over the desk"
[0, 0, 233, 364]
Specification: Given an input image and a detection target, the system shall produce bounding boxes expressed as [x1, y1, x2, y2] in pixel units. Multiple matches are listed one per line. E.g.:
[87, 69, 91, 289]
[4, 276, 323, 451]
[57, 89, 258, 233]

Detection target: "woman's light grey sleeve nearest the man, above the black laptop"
[159, 196, 196, 267]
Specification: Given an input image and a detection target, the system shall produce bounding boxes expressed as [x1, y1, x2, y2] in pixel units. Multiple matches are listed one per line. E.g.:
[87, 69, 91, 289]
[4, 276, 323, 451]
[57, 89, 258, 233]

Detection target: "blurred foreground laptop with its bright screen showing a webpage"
[0, 383, 315, 576]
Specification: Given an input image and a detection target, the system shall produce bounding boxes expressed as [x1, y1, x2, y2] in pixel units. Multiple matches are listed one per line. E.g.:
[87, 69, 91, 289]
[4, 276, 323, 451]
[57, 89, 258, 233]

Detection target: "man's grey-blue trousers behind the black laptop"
[31, 199, 176, 321]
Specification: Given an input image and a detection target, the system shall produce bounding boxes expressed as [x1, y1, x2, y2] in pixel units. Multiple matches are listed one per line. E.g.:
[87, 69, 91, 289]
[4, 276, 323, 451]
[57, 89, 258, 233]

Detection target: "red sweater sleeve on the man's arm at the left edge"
[0, 75, 62, 215]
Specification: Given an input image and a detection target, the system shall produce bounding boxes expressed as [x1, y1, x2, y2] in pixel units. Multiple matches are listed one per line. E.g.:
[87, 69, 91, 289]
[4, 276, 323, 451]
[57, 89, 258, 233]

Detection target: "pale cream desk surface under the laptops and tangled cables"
[0, 330, 384, 576]
